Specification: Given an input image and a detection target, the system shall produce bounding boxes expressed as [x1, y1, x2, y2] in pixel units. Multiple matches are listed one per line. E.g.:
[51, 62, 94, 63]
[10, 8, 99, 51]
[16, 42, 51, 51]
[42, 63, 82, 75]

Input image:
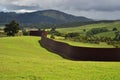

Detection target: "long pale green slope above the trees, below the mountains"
[57, 21, 120, 33]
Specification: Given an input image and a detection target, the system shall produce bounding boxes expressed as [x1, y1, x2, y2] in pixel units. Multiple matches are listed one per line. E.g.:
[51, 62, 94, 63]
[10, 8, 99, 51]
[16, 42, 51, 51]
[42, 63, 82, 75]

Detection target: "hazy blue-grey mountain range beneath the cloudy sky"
[0, 10, 93, 24]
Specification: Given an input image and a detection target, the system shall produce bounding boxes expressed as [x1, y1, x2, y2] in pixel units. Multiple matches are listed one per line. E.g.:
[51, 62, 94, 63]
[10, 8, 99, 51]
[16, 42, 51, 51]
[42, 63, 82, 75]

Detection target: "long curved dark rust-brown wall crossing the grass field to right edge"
[40, 36, 120, 61]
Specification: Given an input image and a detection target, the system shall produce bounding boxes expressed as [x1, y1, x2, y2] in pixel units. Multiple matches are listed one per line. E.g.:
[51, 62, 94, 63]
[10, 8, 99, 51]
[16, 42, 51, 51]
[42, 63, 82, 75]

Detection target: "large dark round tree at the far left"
[4, 20, 19, 36]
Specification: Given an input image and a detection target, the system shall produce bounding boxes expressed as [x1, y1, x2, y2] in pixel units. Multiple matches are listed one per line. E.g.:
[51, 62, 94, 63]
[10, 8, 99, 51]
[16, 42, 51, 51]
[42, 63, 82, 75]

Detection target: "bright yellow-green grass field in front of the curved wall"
[0, 37, 120, 80]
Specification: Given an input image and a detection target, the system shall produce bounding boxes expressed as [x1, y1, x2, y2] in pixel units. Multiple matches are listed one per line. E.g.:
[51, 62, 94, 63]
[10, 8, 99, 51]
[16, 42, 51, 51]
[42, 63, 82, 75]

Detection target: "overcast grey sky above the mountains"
[0, 0, 120, 20]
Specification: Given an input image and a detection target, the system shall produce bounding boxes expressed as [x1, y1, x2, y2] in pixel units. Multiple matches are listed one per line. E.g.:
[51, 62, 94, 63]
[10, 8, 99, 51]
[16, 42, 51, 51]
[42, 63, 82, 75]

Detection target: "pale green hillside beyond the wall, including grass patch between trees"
[57, 21, 120, 38]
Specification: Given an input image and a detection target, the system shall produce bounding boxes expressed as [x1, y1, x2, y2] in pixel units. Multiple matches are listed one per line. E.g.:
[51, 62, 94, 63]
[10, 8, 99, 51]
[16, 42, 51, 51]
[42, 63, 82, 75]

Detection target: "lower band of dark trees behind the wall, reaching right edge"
[62, 30, 120, 47]
